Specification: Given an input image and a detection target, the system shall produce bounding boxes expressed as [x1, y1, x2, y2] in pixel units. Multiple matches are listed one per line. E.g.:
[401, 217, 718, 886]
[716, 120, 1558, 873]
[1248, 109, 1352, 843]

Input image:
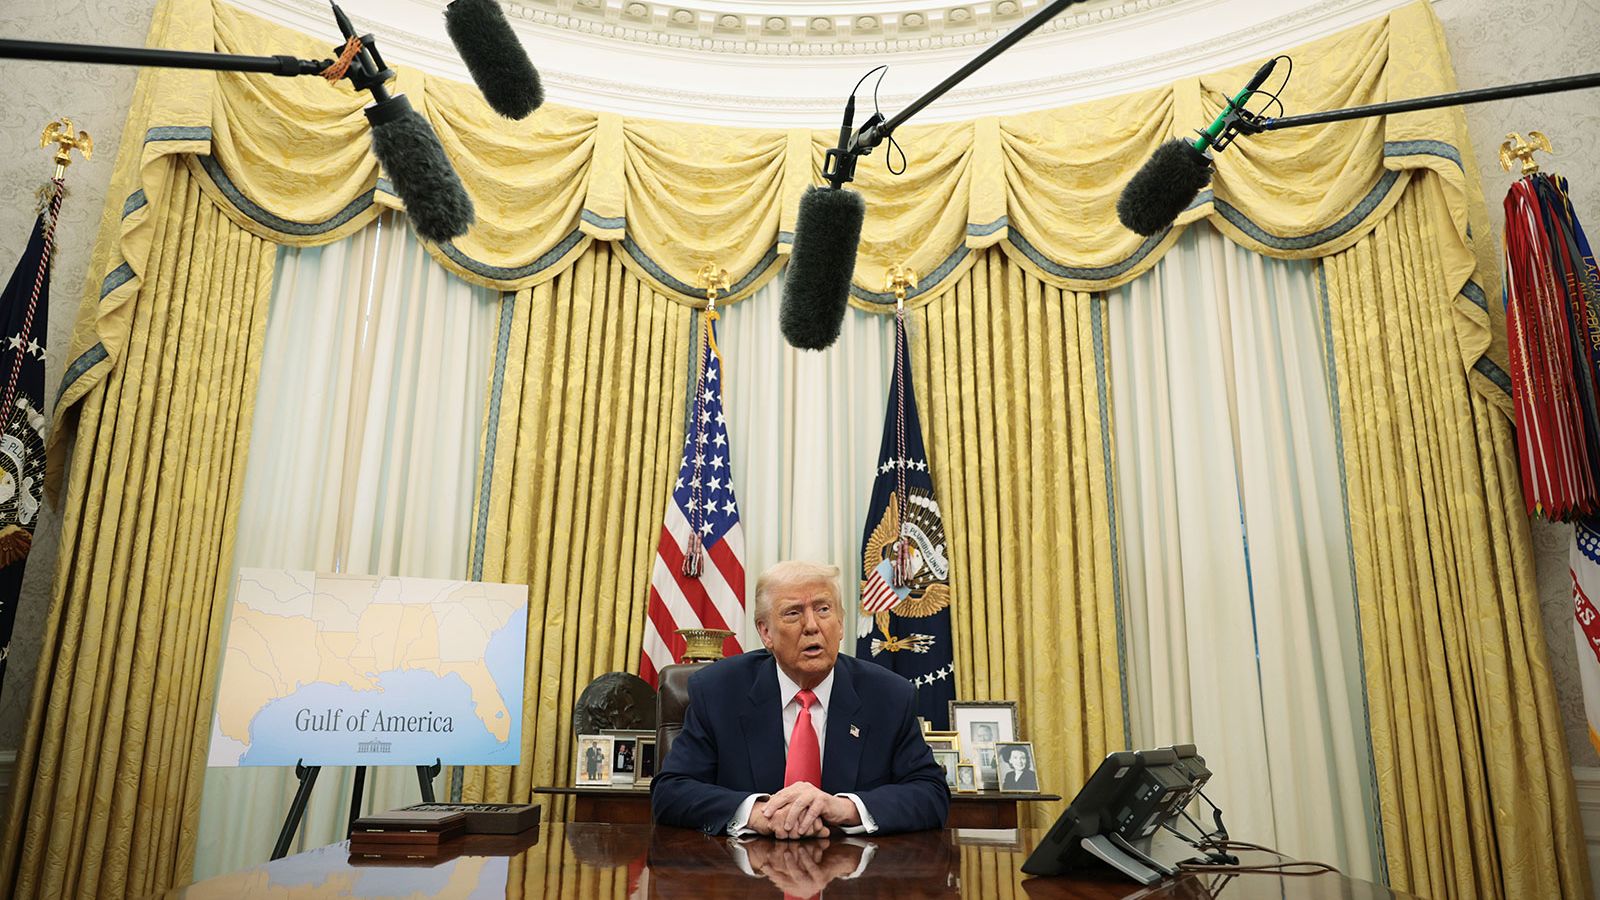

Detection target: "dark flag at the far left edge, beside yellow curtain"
[0, 192, 61, 684]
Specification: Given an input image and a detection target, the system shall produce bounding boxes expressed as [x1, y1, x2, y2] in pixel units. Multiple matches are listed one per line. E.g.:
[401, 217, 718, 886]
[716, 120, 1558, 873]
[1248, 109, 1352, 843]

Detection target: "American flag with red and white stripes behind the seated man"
[638, 312, 744, 685]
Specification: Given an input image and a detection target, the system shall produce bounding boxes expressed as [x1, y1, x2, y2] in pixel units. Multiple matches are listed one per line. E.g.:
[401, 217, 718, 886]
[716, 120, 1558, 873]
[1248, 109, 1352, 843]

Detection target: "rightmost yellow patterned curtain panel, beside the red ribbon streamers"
[1323, 171, 1589, 900]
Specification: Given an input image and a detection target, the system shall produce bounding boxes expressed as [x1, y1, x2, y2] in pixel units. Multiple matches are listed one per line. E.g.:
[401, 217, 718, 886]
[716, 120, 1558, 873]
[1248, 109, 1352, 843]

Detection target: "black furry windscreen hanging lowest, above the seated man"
[778, 186, 867, 351]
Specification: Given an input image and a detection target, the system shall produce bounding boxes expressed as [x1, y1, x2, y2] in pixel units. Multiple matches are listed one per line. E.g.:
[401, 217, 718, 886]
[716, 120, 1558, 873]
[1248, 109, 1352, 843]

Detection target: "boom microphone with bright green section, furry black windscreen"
[1117, 58, 1278, 237]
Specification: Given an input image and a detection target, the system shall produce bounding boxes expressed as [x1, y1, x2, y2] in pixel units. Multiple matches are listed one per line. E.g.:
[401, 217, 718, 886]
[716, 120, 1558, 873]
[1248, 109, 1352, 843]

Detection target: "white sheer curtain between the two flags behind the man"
[717, 277, 894, 643]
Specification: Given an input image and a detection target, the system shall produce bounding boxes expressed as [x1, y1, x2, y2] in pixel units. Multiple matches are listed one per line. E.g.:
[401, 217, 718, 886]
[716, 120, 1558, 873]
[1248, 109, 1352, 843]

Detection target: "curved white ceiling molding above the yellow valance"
[229, 0, 1405, 128]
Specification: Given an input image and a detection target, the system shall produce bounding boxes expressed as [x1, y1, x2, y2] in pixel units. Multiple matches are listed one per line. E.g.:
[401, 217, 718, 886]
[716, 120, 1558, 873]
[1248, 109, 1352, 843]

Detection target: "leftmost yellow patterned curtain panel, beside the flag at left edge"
[0, 165, 274, 898]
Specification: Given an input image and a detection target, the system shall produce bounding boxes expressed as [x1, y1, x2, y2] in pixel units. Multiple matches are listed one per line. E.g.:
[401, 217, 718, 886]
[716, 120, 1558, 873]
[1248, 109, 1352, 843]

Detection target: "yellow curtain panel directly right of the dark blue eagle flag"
[910, 250, 1125, 825]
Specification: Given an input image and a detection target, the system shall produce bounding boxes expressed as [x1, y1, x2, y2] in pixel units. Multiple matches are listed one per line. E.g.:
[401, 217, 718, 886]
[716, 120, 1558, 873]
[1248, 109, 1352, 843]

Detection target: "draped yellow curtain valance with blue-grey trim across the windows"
[59, 0, 1509, 432]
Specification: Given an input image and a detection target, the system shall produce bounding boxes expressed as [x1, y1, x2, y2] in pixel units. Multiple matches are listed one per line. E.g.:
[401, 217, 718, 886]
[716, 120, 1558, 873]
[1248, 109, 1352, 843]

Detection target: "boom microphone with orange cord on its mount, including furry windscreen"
[333, 3, 475, 243]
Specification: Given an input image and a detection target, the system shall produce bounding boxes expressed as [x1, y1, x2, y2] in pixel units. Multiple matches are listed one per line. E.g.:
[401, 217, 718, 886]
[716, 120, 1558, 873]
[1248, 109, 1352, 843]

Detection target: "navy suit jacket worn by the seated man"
[650, 650, 950, 834]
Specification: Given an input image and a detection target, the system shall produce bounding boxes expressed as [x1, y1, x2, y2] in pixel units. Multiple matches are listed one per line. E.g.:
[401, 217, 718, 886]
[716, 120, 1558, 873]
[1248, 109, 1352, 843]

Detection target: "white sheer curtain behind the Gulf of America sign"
[195, 215, 499, 879]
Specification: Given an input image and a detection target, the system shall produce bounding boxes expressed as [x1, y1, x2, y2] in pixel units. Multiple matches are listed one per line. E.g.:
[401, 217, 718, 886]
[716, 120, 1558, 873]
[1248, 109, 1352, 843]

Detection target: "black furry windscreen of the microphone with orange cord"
[366, 96, 475, 243]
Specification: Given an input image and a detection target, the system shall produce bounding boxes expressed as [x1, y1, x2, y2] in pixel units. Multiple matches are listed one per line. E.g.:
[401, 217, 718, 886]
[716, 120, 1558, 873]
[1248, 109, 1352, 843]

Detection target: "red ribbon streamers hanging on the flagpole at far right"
[1504, 173, 1600, 522]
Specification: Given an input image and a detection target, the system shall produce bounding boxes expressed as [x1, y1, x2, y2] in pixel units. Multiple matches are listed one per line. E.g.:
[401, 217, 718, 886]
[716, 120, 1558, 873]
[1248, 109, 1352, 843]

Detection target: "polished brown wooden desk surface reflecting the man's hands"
[166, 822, 1403, 900]
